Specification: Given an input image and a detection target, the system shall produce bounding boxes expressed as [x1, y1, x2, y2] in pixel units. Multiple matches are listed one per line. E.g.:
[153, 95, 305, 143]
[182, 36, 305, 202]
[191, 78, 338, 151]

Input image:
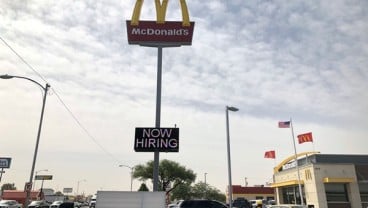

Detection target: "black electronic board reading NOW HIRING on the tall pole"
[134, 128, 179, 152]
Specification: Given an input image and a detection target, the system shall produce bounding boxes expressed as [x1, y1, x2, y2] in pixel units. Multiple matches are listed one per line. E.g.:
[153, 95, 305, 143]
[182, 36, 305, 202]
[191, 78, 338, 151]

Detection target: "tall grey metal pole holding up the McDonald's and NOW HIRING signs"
[153, 46, 162, 191]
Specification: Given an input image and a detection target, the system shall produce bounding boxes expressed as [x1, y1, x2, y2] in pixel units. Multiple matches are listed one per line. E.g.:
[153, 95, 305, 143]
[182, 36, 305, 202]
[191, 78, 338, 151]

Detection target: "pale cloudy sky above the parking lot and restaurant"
[0, 0, 368, 194]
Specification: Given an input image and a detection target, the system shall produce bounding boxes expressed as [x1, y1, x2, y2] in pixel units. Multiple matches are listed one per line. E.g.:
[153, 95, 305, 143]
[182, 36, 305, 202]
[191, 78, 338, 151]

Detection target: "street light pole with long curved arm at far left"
[0, 74, 50, 207]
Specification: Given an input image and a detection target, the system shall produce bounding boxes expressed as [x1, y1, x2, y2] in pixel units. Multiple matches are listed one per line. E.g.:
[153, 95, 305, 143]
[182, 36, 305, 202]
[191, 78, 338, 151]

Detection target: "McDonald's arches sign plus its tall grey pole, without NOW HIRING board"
[126, 0, 194, 191]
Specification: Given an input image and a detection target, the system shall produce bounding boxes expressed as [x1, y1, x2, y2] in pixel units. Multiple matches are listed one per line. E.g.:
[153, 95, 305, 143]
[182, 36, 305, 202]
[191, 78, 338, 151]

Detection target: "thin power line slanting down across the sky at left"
[0, 36, 122, 164]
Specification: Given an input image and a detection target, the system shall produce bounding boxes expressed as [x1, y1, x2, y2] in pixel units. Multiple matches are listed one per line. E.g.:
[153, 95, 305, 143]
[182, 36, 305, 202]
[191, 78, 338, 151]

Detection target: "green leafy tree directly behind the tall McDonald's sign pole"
[133, 159, 196, 192]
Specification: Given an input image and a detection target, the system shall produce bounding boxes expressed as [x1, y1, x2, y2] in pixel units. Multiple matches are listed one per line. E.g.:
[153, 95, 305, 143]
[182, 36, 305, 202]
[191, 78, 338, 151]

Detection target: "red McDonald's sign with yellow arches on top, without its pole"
[126, 0, 194, 46]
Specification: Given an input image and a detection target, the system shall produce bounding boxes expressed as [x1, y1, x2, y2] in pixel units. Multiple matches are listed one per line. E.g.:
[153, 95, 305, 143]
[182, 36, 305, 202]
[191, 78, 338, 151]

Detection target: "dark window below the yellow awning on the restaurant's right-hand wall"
[325, 183, 349, 202]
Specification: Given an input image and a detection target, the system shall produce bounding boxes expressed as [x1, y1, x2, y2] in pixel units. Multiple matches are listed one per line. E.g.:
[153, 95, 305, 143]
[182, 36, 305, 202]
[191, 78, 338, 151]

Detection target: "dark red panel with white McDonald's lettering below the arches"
[126, 20, 194, 46]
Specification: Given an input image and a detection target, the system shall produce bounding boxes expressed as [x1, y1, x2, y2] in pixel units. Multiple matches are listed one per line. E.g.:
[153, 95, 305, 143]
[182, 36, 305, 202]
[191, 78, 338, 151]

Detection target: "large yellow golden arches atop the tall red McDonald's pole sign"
[130, 0, 190, 27]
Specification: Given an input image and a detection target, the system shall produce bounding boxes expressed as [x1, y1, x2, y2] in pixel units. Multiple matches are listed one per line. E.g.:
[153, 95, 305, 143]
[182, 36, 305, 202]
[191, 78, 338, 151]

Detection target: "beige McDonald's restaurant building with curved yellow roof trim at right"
[271, 152, 368, 208]
